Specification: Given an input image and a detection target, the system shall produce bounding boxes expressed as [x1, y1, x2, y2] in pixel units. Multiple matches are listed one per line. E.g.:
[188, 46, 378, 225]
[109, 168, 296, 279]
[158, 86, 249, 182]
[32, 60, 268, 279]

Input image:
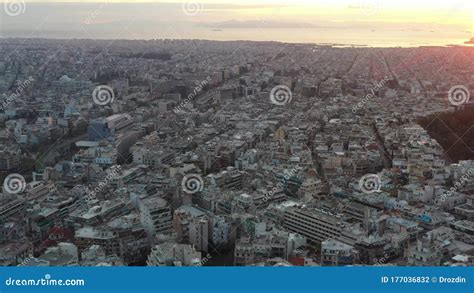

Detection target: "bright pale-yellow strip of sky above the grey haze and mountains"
[10, 0, 474, 28]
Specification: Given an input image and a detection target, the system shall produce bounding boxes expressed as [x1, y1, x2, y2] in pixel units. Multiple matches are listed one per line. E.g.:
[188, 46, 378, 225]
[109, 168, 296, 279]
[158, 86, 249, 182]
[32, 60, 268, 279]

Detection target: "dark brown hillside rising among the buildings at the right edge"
[418, 107, 474, 162]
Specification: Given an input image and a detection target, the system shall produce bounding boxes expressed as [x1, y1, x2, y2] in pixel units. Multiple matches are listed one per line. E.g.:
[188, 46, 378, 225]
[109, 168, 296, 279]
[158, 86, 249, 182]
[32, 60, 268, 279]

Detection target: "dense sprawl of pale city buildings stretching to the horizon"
[0, 38, 474, 266]
